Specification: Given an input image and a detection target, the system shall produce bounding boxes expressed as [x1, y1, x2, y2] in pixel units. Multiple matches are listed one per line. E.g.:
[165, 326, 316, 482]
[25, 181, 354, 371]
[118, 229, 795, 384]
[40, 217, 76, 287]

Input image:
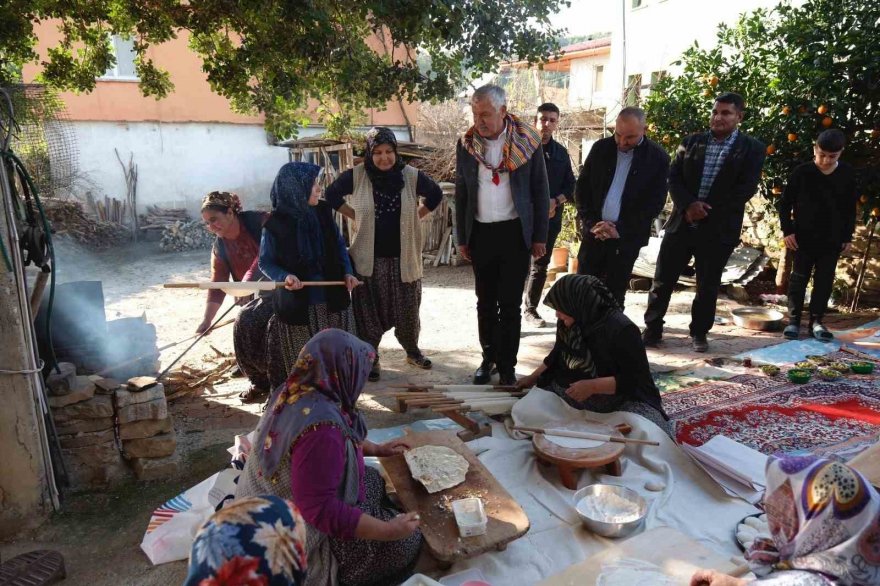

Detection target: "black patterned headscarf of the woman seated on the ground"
[544, 275, 623, 378]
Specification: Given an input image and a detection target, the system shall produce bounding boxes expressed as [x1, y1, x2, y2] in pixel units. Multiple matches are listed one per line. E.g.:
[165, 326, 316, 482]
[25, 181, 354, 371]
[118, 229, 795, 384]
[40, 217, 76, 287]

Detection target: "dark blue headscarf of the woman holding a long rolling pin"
[269, 163, 324, 272]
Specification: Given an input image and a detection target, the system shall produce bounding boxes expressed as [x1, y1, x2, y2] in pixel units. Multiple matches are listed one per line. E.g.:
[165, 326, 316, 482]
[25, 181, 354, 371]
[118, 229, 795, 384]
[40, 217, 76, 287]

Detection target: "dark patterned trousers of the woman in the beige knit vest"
[352, 258, 422, 355]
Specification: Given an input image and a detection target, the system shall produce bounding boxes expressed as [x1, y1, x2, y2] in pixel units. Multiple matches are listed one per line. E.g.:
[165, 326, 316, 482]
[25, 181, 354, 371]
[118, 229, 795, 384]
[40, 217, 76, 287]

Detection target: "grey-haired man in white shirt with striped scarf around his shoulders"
[455, 85, 550, 385]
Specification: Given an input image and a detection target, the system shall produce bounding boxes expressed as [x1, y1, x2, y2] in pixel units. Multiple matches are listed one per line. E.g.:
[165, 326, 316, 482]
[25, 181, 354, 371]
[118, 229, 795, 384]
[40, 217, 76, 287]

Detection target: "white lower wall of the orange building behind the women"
[70, 121, 409, 218]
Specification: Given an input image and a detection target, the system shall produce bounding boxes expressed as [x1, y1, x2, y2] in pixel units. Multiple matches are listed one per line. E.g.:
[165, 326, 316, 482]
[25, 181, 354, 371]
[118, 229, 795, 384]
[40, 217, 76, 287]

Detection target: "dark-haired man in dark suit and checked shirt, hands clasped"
[642, 92, 766, 352]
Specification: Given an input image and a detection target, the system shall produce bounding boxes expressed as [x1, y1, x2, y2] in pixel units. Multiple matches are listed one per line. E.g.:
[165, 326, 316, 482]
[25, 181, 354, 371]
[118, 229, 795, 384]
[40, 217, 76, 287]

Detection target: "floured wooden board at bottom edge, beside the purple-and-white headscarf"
[538, 527, 736, 586]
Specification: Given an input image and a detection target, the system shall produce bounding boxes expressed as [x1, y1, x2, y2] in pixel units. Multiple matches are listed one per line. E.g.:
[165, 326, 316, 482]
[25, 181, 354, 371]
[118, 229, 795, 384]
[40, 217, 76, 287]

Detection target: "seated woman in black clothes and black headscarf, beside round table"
[517, 275, 672, 436]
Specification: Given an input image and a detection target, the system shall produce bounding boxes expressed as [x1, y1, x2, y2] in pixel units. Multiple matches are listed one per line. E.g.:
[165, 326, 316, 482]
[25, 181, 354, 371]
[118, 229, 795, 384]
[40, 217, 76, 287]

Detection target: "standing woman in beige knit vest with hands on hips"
[326, 126, 443, 381]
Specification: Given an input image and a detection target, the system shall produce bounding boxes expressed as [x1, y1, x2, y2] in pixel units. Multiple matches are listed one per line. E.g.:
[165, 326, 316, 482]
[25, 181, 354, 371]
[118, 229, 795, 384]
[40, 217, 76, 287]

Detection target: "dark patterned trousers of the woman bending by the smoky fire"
[232, 297, 274, 391]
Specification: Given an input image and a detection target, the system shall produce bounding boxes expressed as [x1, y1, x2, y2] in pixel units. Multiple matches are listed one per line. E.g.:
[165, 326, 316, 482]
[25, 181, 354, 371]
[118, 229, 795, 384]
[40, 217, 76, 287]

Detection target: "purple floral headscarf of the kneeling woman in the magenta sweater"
[254, 329, 376, 476]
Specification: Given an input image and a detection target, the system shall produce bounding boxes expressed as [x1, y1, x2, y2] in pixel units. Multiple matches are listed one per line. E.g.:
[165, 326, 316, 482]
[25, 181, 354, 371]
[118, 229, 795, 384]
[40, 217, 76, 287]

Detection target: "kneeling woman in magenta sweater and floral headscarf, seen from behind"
[236, 329, 421, 586]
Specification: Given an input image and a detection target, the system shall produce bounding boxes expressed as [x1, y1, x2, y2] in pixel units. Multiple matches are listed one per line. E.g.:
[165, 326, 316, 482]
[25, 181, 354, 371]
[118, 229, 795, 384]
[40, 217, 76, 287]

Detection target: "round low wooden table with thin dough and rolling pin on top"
[532, 421, 630, 490]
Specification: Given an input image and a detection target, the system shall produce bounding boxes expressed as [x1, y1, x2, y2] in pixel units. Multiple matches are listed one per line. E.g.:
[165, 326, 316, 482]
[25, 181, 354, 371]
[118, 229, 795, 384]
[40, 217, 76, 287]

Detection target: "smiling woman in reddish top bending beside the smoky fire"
[196, 191, 272, 401]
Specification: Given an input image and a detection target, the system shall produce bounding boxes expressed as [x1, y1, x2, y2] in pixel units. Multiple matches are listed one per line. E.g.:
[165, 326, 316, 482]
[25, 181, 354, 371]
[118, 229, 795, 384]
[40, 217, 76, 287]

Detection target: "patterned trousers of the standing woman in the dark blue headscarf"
[266, 303, 357, 389]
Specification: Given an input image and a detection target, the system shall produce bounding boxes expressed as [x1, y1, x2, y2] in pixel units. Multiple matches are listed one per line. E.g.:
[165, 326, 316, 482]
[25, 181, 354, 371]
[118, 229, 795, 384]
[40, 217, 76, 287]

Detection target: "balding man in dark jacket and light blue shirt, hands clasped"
[575, 107, 669, 305]
